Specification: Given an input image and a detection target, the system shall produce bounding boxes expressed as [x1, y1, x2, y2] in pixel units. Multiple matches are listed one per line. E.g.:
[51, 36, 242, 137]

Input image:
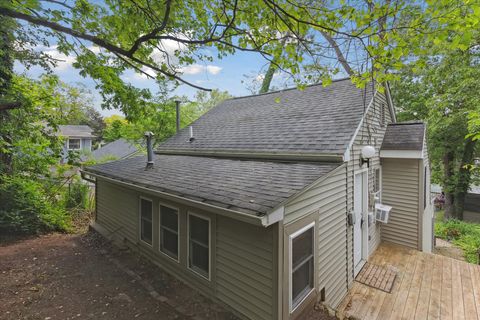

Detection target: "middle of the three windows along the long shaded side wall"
[160, 205, 178, 261]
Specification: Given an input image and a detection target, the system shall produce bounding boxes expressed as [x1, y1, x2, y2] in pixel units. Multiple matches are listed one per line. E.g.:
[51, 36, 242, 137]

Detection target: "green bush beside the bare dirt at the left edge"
[0, 176, 70, 234]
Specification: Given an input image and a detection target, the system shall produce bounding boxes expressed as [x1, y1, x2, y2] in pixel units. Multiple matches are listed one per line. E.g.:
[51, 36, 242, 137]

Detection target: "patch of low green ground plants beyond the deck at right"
[435, 212, 480, 264]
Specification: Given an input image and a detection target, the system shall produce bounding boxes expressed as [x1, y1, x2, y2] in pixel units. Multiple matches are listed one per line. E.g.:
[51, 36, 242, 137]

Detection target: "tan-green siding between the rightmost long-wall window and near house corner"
[216, 217, 277, 319]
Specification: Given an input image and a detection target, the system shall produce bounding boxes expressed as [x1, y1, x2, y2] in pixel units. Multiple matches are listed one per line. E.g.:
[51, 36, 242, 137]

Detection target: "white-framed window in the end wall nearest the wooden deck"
[290, 223, 315, 310]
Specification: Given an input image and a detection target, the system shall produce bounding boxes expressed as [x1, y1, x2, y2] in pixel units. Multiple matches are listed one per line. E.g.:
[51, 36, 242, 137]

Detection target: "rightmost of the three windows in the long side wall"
[188, 214, 210, 279]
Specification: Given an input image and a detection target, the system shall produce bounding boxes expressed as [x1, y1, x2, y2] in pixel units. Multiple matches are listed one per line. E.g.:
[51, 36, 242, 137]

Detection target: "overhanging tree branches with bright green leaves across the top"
[0, 0, 480, 119]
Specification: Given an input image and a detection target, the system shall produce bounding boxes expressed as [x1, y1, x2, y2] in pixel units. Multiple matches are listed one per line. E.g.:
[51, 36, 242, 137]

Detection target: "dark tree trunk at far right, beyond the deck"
[454, 138, 476, 220]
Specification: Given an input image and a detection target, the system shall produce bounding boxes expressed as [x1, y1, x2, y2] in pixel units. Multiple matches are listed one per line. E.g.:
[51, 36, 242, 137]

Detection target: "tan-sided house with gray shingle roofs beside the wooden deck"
[81, 79, 433, 319]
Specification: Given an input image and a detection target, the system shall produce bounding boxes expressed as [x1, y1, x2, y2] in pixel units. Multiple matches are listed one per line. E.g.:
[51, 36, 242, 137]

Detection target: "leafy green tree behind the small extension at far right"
[393, 49, 480, 219]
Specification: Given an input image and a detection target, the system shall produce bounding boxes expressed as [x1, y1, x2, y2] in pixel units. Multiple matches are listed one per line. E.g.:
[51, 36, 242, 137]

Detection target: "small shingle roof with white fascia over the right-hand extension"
[381, 122, 425, 150]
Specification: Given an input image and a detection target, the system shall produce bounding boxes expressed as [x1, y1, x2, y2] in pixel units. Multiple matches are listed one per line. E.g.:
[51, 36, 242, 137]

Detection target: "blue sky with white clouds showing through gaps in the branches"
[15, 46, 278, 116]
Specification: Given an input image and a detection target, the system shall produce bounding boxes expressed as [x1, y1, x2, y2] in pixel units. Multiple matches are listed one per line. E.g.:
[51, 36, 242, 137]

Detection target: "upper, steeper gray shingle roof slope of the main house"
[159, 79, 372, 154]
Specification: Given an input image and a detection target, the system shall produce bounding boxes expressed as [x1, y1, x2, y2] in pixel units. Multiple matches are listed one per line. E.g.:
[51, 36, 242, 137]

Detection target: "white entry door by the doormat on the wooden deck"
[353, 172, 368, 276]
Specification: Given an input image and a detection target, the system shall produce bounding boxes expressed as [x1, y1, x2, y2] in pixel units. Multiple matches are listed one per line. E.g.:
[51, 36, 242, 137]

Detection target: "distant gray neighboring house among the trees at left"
[58, 125, 95, 161]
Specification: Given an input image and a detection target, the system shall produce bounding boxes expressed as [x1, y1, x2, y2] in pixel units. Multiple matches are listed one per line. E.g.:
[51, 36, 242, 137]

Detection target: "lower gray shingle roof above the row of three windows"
[85, 155, 340, 215]
